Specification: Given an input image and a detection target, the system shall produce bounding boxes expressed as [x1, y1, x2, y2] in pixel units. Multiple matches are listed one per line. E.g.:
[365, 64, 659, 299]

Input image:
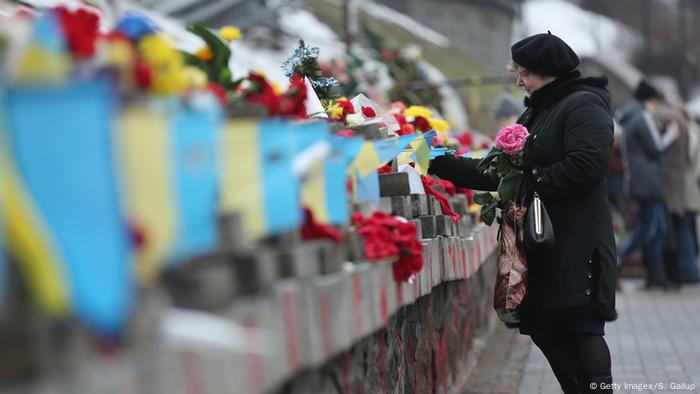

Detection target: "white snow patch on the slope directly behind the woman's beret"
[513, 0, 641, 59]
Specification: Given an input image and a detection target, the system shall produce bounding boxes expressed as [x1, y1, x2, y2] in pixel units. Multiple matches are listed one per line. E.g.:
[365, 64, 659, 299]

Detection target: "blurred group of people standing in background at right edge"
[608, 80, 700, 289]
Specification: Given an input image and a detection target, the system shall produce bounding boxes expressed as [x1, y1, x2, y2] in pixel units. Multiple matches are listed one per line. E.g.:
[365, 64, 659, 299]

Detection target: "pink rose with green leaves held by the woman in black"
[474, 124, 529, 225]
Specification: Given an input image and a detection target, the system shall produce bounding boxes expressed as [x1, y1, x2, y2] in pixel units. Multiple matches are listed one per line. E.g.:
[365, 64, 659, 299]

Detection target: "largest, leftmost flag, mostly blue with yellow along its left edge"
[0, 81, 134, 336]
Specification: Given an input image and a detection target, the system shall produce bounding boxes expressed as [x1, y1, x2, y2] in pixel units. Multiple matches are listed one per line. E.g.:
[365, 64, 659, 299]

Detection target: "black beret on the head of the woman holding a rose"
[510, 32, 580, 76]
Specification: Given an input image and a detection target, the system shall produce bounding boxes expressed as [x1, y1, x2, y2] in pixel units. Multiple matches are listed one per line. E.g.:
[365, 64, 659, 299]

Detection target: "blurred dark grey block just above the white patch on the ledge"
[163, 252, 240, 310]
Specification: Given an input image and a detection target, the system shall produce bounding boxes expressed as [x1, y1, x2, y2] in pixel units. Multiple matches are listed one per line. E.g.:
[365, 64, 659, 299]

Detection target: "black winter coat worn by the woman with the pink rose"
[430, 71, 617, 333]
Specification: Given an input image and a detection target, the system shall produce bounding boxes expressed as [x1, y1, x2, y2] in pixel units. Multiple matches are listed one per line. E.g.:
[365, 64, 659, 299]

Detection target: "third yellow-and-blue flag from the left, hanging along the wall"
[220, 119, 302, 240]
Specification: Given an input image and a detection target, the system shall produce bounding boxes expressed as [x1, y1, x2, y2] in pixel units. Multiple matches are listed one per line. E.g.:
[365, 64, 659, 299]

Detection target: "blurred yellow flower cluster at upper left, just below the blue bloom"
[139, 34, 187, 95]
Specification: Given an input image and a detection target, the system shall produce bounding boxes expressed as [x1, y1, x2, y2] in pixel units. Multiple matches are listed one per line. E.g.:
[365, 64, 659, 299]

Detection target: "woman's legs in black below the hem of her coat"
[531, 330, 613, 394]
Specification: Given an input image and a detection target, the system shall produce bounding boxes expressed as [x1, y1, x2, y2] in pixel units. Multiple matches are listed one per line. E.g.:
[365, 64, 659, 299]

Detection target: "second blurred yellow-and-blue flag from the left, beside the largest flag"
[117, 101, 220, 282]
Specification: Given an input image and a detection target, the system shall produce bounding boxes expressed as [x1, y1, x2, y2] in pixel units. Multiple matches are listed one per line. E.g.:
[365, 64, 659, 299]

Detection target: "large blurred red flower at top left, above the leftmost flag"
[56, 6, 100, 59]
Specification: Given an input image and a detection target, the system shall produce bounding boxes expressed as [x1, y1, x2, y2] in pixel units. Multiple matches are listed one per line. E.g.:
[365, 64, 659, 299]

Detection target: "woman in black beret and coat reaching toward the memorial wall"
[430, 33, 617, 393]
